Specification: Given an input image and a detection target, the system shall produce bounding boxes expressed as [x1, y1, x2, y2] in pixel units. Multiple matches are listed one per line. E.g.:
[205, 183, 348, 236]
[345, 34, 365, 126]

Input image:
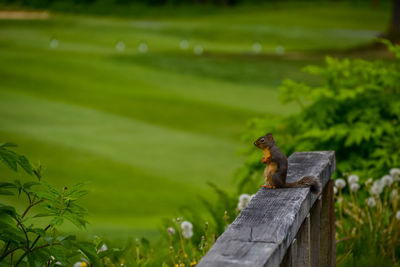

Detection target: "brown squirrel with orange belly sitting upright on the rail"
[254, 133, 321, 194]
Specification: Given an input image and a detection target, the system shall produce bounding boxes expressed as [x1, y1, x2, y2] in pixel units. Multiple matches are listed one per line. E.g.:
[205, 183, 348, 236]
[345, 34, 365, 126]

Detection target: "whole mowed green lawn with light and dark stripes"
[0, 3, 389, 243]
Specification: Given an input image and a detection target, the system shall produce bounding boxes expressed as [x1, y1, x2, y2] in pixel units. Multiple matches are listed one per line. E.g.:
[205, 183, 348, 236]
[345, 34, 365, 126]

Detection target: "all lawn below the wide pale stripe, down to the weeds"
[0, 131, 203, 242]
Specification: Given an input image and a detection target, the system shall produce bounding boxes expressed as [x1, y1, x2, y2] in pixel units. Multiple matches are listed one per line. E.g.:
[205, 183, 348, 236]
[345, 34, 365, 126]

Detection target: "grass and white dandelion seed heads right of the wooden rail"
[335, 169, 400, 266]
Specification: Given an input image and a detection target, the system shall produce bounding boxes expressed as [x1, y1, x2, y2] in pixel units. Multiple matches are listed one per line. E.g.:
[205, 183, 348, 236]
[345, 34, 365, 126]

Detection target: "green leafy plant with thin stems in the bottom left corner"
[0, 146, 93, 266]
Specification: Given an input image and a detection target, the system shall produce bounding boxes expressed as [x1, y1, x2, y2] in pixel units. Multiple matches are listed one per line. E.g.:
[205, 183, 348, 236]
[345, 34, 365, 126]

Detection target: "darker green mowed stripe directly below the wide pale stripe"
[0, 131, 205, 218]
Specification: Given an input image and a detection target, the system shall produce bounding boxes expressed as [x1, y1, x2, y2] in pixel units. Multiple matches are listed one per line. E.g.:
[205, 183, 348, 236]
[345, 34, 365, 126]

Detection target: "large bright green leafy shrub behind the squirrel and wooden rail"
[239, 41, 400, 193]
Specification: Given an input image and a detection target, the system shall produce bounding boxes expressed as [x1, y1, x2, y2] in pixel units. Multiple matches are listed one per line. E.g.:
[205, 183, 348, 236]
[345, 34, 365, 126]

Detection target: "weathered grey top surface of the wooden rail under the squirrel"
[197, 151, 335, 267]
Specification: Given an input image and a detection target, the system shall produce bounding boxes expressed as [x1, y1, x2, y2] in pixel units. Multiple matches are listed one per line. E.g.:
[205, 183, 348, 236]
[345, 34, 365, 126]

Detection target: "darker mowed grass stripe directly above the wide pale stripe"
[0, 48, 296, 140]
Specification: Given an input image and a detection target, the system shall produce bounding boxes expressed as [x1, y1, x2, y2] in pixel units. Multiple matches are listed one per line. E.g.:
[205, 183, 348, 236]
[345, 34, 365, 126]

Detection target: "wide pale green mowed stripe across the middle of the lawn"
[0, 91, 244, 186]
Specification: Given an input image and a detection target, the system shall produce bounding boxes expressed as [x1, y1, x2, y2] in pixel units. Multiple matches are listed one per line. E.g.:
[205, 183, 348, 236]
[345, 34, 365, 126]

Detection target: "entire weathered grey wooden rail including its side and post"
[197, 151, 336, 267]
